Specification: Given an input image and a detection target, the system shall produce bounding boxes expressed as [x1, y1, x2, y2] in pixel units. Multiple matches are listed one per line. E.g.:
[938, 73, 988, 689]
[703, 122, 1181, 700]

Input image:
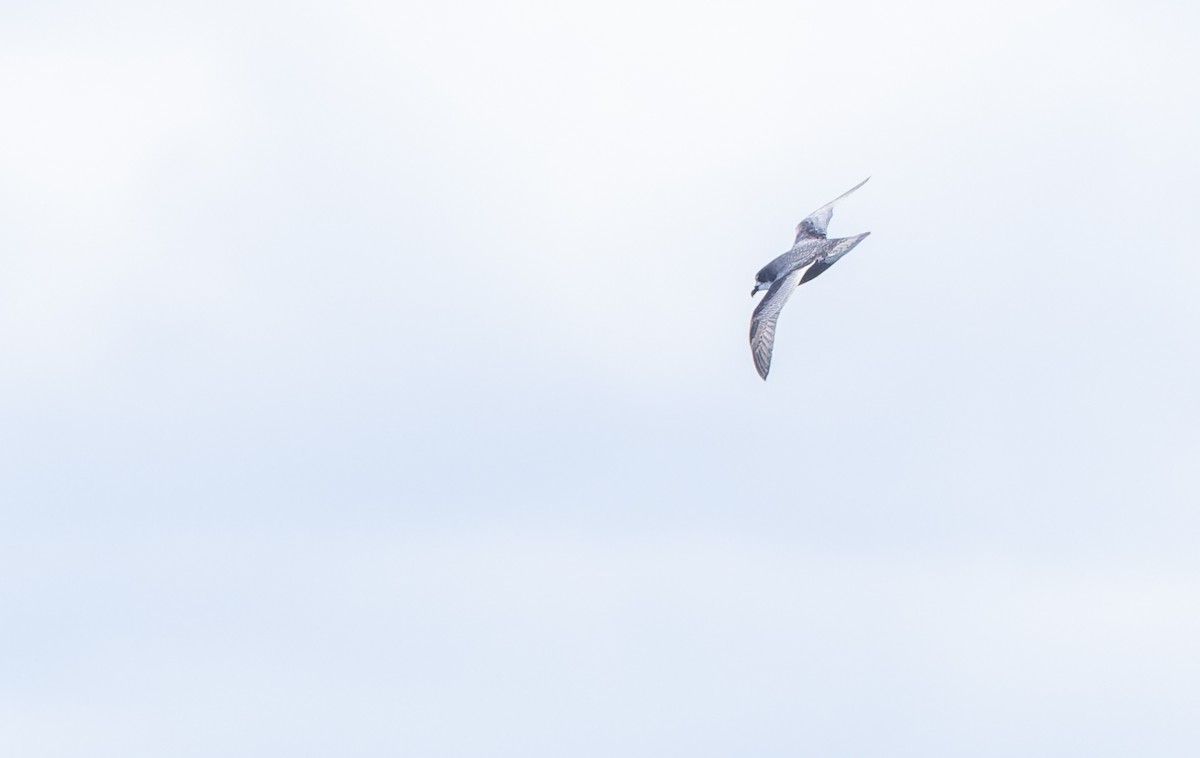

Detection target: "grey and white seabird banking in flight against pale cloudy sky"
[750, 176, 871, 381]
